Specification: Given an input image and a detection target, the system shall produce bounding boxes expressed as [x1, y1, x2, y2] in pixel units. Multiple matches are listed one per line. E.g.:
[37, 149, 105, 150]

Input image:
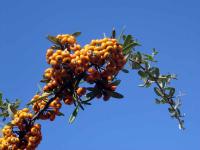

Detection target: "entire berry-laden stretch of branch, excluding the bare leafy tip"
[0, 34, 126, 150]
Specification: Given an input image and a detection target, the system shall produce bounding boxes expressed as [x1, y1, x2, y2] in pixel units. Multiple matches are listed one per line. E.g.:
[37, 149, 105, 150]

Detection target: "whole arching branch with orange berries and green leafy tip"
[0, 30, 183, 150]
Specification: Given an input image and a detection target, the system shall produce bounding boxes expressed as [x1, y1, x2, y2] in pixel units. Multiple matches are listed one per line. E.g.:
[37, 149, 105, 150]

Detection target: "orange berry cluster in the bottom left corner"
[0, 108, 42, 150]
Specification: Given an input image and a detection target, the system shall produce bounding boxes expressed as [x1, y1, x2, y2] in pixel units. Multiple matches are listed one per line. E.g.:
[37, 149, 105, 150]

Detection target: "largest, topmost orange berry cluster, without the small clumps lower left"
[43, 35, 126, 101]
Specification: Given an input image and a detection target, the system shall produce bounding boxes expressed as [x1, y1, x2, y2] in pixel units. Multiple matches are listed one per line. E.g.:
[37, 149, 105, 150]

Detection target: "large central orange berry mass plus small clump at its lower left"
[36, 34, 126, 120]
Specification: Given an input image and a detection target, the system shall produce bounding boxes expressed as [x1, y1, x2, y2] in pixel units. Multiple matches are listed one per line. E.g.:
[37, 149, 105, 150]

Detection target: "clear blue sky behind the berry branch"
[0, 0, 200, 150]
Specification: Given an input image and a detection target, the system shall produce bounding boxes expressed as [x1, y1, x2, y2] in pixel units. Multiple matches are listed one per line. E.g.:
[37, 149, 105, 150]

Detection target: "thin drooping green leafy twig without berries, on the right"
[128, 49, 185, 129]
